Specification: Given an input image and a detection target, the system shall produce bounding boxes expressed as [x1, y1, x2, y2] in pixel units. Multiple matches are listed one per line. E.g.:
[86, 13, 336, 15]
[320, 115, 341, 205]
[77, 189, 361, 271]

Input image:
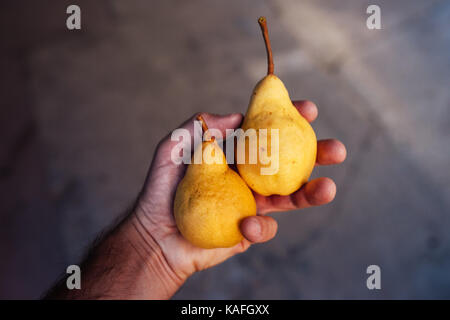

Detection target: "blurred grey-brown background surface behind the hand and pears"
[0, 0, 450, 299]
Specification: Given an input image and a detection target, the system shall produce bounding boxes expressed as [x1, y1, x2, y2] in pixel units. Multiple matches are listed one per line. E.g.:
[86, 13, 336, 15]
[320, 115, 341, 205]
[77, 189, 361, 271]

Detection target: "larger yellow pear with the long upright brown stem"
[237, 17, 317, 196]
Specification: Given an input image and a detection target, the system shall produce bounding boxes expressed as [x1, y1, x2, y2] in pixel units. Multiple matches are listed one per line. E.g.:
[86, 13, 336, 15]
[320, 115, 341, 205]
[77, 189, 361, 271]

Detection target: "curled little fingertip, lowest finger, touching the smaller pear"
[240, 216, 278, 243]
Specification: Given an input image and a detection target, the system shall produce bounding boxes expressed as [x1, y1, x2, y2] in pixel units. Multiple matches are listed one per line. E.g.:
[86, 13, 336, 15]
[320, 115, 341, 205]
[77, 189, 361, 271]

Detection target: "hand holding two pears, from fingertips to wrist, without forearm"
[134, 101, 346, 290]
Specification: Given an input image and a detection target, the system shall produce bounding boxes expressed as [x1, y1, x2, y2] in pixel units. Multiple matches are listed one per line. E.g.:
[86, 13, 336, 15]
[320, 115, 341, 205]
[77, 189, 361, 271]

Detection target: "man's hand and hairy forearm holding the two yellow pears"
[46, 101, 346, 299]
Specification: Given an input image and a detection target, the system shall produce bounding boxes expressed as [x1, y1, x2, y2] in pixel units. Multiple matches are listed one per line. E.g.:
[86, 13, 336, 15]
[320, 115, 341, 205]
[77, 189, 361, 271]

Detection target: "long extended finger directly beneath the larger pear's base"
[255, 178, 336, 214]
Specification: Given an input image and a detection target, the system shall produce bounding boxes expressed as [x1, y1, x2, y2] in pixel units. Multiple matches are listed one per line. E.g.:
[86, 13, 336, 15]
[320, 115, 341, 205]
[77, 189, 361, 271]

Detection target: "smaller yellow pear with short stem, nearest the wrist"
[174, 116, 256, 249]
